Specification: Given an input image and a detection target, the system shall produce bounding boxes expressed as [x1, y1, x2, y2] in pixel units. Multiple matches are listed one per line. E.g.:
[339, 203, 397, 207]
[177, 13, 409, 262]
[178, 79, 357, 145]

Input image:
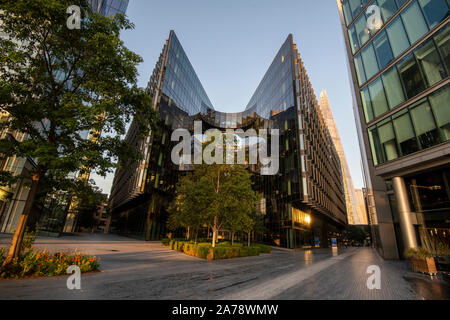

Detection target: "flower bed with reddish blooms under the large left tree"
[0, 249, 100, 279]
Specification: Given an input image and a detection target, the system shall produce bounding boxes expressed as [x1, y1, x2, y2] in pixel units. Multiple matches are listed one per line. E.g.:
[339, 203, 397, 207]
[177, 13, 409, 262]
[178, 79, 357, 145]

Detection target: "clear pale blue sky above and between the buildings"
[92, 0, 363, 193]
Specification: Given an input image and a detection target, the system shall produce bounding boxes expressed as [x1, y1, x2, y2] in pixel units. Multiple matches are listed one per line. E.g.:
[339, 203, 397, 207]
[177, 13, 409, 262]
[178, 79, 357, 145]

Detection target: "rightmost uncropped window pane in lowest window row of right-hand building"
[411, 100, 441, 149]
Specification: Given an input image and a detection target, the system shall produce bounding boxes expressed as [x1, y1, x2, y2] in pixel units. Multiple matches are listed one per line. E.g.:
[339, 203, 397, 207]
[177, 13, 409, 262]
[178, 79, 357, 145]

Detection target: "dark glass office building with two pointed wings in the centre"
[110, 31, 346, 248]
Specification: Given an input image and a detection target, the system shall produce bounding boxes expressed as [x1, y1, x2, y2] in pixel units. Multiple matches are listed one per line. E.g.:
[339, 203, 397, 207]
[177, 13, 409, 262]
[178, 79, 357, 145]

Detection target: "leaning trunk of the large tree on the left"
[4, 169, 43, 265]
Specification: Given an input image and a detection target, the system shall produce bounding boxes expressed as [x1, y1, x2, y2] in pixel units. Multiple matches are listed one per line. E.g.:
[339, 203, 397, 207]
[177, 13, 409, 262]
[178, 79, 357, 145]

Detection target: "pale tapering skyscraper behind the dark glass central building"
[319, 90, 367, 225]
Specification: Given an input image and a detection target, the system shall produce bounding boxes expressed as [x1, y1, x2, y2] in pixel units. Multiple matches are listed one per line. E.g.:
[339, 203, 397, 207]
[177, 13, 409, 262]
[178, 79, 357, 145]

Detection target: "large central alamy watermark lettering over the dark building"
[171, 121, 280, 176]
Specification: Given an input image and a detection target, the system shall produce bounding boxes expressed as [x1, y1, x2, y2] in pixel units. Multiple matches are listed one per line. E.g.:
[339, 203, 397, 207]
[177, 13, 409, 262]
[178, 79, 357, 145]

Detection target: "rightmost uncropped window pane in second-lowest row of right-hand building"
[414, 40, 446, 86]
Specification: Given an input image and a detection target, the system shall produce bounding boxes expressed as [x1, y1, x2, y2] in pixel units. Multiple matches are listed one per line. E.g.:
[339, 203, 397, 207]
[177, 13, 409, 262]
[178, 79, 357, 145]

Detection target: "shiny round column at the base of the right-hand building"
[392, 177, 417, 249]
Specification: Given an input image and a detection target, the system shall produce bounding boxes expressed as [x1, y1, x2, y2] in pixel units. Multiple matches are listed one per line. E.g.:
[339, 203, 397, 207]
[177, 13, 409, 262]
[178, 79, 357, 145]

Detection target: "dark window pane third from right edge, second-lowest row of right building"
[398, 53, 425, 98]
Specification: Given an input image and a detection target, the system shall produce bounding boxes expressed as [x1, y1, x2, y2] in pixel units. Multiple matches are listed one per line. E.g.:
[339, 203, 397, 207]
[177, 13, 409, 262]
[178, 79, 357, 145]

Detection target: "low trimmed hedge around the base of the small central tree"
[161, 239, 272, 260]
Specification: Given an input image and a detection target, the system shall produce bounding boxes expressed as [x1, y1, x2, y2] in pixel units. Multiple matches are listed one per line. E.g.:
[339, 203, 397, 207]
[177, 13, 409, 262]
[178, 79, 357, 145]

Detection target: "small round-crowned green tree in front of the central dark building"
[172, 164, 257, 247]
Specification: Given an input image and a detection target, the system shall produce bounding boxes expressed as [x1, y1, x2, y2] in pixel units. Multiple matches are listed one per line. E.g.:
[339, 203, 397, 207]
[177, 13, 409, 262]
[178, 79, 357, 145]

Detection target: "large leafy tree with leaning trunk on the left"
[0, 0, 155, 263]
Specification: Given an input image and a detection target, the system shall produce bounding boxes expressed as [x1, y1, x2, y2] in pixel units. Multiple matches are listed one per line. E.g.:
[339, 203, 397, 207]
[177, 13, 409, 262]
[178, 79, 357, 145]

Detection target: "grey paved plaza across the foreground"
[0, 234, 450, 300]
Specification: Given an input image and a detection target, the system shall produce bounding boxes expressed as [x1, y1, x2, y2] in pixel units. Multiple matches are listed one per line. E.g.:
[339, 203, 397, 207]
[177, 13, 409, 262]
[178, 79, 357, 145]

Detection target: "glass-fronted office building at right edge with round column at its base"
[337, 0, 450, 259]
